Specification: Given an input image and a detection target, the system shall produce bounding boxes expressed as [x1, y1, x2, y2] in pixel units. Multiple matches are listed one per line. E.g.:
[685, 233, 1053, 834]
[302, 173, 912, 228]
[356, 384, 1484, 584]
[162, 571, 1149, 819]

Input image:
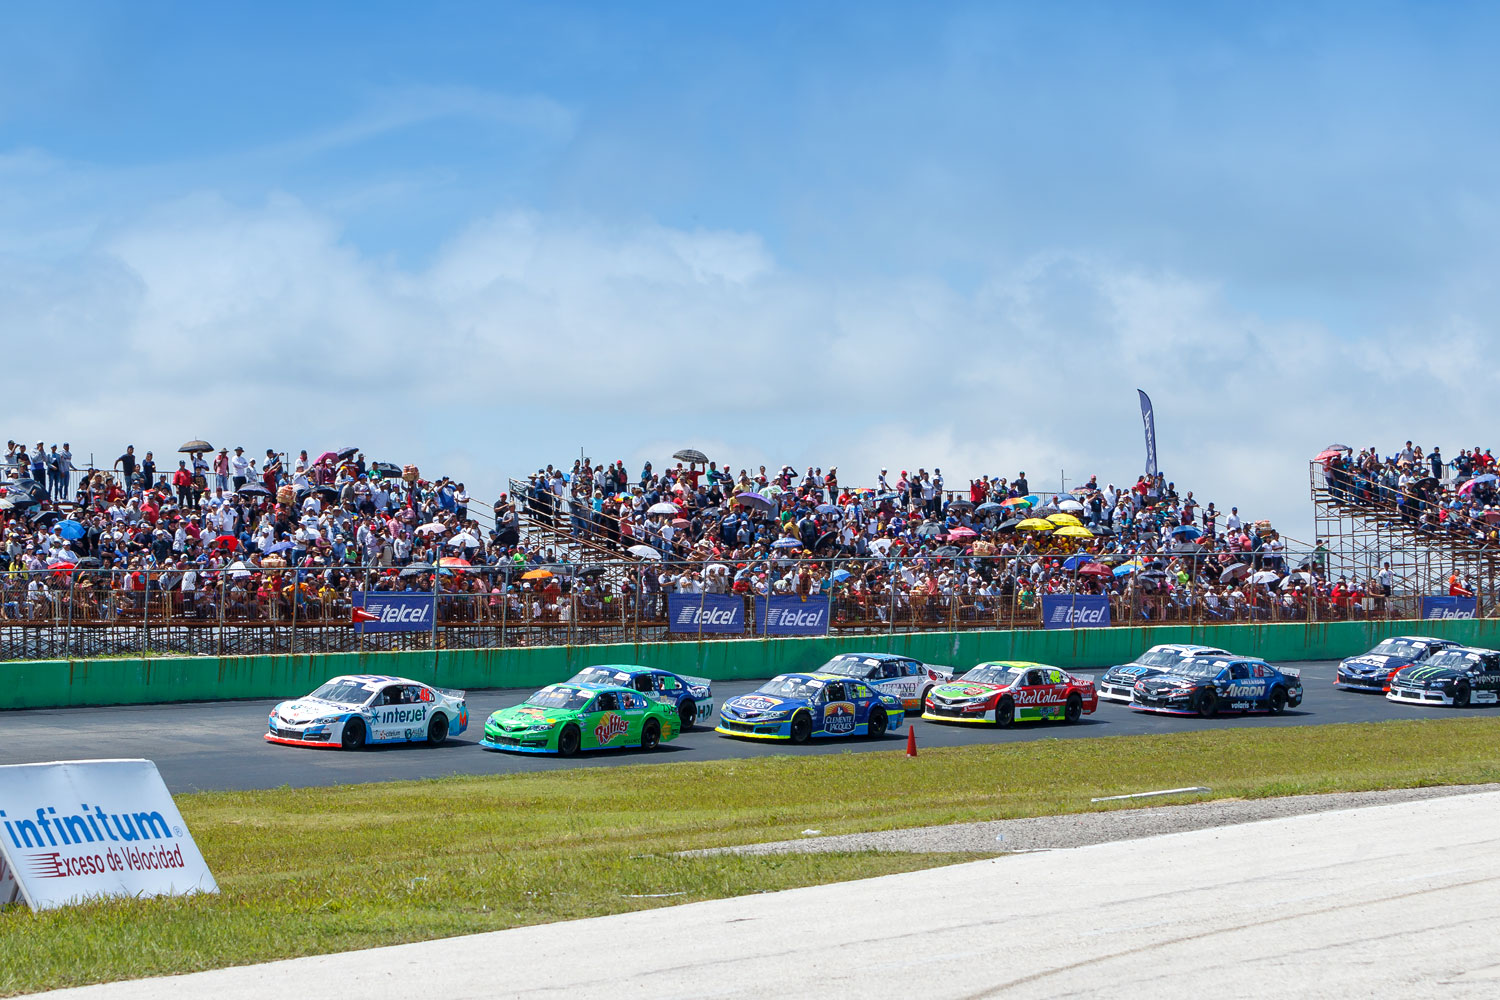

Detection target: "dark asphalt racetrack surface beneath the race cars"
[0, 660, 1458, 792]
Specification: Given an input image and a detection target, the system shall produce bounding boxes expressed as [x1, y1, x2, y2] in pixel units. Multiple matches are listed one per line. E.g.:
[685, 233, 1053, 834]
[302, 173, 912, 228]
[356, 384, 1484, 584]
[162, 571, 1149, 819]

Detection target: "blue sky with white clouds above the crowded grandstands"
[0, 1, 1500, 537]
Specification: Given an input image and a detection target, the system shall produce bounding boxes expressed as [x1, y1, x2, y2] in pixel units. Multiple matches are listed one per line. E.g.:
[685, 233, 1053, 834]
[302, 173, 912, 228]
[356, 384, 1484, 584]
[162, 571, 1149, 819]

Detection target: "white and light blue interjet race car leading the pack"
[266, 673, 468, 750]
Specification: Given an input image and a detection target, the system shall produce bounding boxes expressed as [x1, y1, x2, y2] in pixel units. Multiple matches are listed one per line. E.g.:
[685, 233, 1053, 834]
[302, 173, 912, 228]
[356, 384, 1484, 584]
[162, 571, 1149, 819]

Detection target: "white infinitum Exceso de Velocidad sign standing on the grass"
[0, 760, 219, 910]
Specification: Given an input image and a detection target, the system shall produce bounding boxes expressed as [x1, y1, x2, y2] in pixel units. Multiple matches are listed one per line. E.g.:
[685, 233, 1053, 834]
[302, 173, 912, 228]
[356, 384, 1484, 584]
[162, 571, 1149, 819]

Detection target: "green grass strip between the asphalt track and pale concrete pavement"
[0, 718, 1500, 994]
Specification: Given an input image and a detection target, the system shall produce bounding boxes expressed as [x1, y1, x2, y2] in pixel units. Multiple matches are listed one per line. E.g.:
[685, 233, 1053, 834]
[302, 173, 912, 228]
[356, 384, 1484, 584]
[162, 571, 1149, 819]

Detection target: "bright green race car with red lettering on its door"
[479, 681, 681, 757]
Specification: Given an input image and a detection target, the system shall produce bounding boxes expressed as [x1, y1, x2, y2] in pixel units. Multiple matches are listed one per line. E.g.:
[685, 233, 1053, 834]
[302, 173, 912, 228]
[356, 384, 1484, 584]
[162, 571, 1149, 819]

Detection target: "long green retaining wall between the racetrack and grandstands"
[0, 619, 1500, 709]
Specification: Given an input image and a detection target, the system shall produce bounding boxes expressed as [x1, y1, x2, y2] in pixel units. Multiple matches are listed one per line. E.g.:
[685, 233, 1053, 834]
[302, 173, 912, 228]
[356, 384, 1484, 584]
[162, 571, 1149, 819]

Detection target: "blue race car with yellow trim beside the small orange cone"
[714, 673, 906, 744]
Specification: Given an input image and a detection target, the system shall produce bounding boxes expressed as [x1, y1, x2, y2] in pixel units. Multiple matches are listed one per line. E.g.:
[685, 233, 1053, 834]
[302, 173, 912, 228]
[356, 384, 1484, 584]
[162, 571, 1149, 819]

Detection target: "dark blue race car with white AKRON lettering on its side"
[1130, 657, 1302, 718]
